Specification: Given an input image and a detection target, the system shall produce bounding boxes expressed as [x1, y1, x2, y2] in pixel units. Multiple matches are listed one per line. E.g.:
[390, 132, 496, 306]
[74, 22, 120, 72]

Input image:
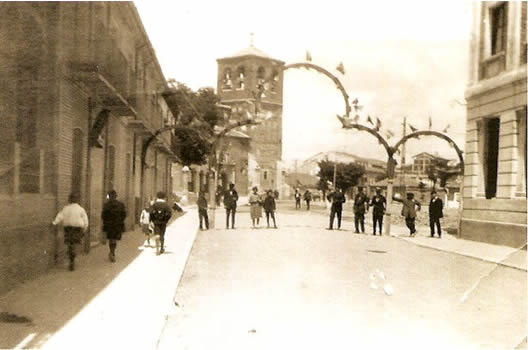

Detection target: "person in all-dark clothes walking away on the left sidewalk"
[101, 190, 126, 262]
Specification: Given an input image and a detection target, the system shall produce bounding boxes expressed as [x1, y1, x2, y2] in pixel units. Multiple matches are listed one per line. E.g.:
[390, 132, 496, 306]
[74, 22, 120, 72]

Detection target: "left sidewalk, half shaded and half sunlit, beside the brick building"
[0, 207, 198, 349]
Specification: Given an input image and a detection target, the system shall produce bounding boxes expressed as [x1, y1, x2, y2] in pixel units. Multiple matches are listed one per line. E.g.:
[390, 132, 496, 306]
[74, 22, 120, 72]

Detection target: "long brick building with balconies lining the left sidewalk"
[0, 2, 174, 293]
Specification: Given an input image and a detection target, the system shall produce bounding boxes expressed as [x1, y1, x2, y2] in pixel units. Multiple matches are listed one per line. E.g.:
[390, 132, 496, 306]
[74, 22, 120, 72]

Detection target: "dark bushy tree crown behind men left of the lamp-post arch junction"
[317, 160, 365, 192]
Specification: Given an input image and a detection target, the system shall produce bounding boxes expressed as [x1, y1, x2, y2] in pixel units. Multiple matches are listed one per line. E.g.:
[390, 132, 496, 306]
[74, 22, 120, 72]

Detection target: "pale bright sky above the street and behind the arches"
[134, 0, 471, 162]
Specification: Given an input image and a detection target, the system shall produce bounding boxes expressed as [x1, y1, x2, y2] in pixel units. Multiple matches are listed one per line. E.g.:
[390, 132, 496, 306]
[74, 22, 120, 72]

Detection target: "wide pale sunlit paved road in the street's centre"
[158, 209, 527, 349]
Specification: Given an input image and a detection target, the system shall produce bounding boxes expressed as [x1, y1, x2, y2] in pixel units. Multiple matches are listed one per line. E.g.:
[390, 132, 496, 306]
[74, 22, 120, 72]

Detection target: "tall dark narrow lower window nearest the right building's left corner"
[484, 118, 500, 199]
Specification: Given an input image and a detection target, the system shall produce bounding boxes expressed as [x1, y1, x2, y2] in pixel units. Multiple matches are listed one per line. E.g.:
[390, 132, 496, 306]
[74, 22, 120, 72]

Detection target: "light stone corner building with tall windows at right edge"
[461, 1, 527, 247]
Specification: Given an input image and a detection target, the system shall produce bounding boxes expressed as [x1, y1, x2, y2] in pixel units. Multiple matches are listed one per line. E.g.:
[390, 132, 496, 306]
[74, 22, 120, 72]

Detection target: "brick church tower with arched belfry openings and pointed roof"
[217, 44, 284, 191]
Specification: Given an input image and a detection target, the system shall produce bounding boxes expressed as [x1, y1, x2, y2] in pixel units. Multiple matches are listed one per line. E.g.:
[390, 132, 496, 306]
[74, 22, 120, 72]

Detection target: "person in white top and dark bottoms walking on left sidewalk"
[53, 193, 88, 271]
